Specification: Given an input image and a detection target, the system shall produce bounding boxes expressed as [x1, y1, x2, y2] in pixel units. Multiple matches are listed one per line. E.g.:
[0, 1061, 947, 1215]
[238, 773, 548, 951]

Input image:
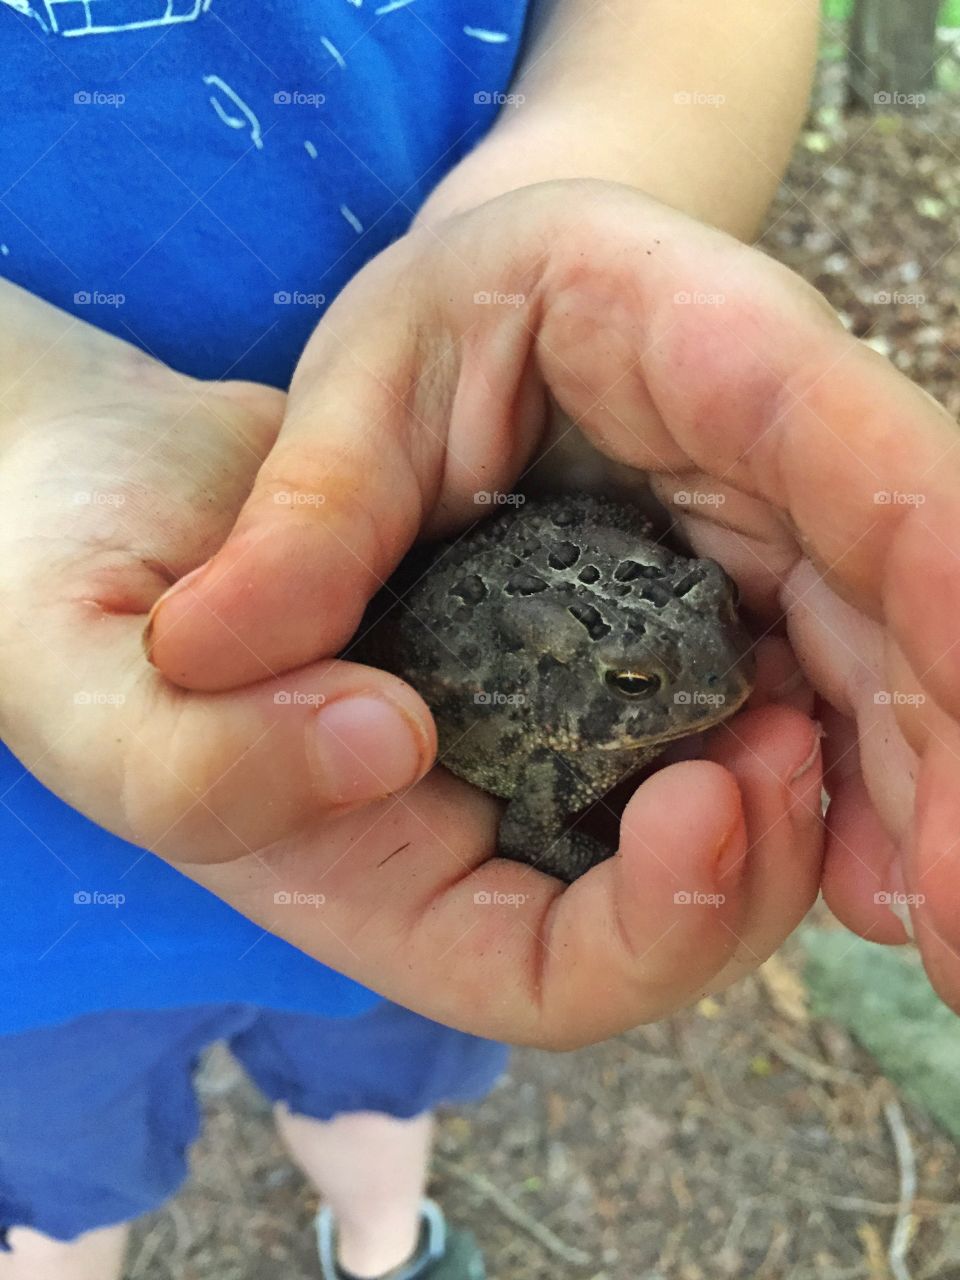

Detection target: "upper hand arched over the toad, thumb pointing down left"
[152, 182, 960, 1018]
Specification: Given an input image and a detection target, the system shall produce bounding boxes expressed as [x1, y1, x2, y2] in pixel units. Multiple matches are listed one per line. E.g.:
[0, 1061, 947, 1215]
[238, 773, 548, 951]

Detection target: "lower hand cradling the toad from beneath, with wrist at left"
[0, 264, 820, 1046]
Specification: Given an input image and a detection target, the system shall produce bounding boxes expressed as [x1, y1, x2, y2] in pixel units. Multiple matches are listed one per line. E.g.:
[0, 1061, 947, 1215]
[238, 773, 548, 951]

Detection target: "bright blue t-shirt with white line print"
[0, 0, 527, 1032]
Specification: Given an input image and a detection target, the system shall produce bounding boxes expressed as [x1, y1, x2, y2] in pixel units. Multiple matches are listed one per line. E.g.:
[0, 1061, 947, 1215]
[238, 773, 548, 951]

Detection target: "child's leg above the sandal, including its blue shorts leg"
[230, 1001, 508, 1276]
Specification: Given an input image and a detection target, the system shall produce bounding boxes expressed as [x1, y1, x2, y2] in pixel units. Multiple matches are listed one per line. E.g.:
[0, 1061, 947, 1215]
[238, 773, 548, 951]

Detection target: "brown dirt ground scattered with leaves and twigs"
[128, 72, 960, 1280]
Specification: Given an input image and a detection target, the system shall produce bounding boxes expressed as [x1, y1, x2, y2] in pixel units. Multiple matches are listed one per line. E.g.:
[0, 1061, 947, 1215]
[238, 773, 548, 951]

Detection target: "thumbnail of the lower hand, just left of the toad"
[310, 694, 430, 805]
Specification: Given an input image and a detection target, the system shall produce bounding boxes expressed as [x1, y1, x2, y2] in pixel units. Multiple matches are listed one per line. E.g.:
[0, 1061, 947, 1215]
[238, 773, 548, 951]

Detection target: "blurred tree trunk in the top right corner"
[849, 0, 941, 111]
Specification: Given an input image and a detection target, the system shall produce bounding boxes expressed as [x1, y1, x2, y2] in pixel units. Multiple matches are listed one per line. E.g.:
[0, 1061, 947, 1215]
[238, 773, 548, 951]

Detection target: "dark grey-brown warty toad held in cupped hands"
[358, 495, 754, 881]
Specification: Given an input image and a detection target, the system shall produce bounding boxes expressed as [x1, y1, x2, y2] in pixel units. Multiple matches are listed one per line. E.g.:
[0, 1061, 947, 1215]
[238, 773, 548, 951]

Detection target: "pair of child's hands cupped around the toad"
[0, 182, 960, 1047]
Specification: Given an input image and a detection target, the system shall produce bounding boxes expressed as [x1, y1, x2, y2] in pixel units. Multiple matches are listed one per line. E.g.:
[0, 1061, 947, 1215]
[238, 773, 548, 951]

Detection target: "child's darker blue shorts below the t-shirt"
[0, 1001, 508, 1240]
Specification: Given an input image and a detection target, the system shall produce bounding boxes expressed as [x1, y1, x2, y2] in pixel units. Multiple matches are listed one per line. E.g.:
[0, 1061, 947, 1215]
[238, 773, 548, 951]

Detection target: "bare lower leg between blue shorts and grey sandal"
[276, 1105, 433, 1276]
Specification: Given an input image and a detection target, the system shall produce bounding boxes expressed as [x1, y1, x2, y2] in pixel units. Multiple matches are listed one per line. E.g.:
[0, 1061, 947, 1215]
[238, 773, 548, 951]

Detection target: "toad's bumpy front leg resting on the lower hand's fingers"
[497, 746, 630, 883]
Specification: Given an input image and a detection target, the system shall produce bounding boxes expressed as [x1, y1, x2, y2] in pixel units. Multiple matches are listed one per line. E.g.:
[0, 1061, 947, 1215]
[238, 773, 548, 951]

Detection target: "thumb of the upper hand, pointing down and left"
[145, 238, 460, 690]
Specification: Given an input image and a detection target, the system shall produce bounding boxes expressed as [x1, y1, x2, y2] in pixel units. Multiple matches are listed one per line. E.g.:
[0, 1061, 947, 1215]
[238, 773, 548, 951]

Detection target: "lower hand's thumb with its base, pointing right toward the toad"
[4, 611, 436, 863]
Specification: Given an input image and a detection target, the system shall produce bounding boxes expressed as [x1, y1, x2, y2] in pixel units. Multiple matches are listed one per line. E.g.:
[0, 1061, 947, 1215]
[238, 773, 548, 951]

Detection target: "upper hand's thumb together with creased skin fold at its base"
[145, 212, 543, 690]
